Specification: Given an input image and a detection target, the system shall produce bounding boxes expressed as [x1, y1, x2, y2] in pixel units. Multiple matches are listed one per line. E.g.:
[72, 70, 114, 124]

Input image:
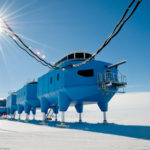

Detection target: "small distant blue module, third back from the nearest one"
[6, 92, 17, 117]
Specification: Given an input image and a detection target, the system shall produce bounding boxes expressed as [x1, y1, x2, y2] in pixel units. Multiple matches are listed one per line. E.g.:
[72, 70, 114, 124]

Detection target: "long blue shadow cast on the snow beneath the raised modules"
[5, 120, 150, 140]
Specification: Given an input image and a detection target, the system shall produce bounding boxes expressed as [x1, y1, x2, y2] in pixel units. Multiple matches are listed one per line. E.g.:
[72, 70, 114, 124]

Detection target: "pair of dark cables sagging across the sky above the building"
[2, 0, 142, 70]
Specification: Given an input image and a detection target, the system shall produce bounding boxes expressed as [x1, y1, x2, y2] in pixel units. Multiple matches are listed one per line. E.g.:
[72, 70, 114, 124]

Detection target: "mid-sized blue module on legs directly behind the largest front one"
[17, 82, 40, 120]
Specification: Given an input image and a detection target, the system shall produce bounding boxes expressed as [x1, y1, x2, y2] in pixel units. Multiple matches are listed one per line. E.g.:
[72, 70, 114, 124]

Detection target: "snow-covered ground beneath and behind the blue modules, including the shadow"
[0, 93, 150, 150]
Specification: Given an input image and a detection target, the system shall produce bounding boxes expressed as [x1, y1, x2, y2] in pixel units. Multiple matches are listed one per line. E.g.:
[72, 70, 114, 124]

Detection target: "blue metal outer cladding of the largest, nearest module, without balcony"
[37, 60, 117, 111]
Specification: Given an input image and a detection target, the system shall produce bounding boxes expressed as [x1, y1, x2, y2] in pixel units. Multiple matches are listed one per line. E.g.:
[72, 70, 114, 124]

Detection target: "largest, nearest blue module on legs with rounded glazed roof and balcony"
[37, 52, 126, 123]
